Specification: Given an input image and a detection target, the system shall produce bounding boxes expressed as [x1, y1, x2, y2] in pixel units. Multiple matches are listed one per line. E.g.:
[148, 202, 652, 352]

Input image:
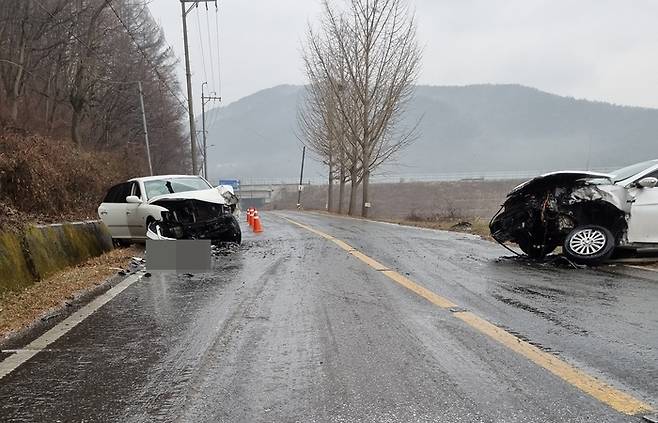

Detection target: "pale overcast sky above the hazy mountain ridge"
[150, 0, 658, 107]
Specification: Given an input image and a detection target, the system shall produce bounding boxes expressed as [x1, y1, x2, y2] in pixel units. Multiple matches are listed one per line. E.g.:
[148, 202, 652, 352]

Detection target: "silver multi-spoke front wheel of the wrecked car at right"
[564, 225, 615, 264]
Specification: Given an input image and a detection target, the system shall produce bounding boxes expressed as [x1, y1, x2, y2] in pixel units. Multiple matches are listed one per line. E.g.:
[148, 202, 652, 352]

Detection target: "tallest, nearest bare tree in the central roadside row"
[305, 0, 421, 216]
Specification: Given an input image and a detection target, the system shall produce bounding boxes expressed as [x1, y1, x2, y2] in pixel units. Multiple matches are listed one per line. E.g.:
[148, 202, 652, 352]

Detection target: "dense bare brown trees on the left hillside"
[0, 0, 187, 172]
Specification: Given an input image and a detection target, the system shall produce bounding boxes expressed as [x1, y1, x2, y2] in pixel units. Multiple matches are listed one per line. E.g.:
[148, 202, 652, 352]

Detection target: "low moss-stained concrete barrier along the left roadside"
[0, 221, 112, 294]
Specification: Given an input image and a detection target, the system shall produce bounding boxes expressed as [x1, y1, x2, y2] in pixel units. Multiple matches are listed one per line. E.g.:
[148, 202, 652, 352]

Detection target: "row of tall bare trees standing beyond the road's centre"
[298, 0, 421, 216]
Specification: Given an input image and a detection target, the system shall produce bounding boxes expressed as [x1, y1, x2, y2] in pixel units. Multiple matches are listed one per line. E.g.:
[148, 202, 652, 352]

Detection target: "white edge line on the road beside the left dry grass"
[0, 273, 142, 379]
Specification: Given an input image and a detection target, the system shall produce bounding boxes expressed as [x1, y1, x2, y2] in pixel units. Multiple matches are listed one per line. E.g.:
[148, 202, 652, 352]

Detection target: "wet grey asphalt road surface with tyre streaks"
[0, 212, 658, 422]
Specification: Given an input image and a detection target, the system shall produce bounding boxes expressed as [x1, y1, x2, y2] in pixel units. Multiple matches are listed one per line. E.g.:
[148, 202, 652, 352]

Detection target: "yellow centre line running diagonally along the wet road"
[281, 216, 653, 415]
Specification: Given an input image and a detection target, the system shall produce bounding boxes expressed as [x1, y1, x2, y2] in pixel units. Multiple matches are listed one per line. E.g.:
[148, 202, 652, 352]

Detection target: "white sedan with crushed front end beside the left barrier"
[98, 175, 242, 244]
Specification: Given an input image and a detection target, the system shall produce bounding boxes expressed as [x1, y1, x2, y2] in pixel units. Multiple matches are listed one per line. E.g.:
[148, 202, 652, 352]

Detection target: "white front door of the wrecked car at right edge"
[628, 172, 658, 243]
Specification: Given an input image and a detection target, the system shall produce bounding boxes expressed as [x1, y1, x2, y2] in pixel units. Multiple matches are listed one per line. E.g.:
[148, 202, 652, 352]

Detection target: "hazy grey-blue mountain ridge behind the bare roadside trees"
[206, 84, 658, 180]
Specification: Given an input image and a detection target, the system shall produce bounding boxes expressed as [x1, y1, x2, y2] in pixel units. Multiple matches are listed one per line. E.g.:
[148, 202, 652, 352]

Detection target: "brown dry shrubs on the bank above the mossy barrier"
[0, 132, 143, 229]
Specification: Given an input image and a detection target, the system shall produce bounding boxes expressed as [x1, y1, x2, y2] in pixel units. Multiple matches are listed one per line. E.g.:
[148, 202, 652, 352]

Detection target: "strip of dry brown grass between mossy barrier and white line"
[0, 246, 143, 340]
